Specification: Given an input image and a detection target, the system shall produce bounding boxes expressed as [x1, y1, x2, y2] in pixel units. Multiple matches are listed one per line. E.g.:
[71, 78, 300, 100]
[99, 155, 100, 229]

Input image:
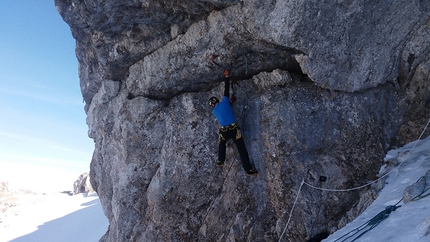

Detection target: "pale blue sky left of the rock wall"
[0, 0, 94, 191]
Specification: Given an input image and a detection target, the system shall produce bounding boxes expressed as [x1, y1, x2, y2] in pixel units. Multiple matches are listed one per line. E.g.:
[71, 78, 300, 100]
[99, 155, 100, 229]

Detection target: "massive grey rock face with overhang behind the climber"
[55, 0, 430, 241]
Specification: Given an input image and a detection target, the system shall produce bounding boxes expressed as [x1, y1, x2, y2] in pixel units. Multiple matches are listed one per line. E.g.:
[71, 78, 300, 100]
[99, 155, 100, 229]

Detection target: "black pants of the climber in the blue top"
[218, 124, 252, 171]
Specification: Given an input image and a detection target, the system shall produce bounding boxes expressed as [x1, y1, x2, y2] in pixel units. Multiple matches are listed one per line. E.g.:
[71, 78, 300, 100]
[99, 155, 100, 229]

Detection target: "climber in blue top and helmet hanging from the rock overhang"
[209, 70, 258, 175]
